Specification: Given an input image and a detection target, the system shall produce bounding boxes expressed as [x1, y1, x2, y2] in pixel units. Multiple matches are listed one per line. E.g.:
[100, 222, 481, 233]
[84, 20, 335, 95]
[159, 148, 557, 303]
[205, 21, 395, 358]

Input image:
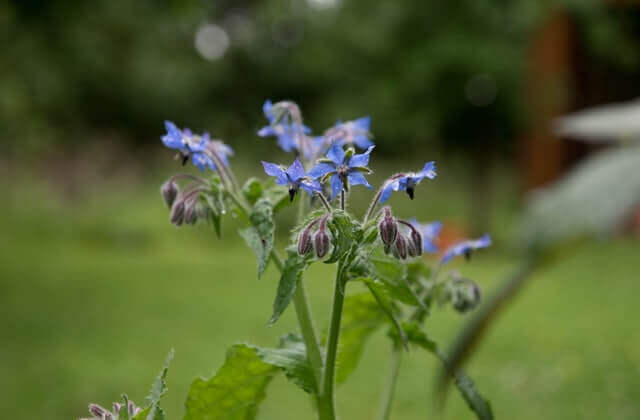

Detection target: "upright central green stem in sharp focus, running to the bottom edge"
[320, 261, 345, 419]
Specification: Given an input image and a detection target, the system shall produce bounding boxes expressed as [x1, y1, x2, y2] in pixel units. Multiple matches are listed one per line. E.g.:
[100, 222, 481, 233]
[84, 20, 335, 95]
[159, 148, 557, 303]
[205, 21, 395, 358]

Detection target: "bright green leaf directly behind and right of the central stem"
[336, 293, 386, 383]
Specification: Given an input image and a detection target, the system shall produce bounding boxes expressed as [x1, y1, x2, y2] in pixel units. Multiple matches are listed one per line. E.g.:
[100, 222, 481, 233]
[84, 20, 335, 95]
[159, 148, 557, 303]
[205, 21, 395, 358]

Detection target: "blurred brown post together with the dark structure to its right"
[520, 1, 640, 191]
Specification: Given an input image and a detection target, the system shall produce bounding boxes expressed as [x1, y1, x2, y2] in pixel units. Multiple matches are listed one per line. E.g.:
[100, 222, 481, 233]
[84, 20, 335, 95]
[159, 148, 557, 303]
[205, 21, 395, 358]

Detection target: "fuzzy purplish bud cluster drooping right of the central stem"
[378, 207, 422, 260]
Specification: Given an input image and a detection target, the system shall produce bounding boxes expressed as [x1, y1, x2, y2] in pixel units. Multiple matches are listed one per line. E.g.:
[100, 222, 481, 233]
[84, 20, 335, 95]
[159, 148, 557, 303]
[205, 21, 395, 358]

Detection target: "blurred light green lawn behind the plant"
[0, 171, 640, 420]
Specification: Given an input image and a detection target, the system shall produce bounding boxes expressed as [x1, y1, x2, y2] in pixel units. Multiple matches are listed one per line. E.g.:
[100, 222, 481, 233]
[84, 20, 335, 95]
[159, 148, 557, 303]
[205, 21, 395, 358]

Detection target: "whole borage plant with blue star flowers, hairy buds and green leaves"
[82, 101, 492, 420]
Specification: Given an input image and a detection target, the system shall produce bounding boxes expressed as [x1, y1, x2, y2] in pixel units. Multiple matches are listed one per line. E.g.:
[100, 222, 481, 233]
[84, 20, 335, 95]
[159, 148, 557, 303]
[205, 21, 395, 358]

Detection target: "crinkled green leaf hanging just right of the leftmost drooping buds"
[239, 198, 275, 279]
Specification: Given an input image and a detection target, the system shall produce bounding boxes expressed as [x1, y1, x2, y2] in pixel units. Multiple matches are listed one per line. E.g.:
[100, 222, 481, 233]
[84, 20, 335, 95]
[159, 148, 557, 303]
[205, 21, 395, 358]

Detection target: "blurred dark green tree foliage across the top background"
[0, 0, 638, 158]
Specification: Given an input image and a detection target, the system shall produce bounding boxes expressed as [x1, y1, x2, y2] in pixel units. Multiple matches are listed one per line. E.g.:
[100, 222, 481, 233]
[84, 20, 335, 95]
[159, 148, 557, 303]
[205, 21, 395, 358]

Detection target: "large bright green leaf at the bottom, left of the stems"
[184, 344, 279, 420]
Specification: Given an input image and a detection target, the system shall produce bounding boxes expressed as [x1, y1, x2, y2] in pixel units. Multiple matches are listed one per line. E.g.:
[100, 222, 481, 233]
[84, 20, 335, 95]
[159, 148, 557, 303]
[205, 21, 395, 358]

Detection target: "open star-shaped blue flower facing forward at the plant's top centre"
[309, 143, 375, 200]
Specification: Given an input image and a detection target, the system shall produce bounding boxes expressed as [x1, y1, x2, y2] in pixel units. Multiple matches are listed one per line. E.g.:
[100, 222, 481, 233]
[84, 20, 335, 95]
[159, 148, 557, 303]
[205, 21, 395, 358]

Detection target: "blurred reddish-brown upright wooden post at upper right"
[520, 11, 572, 190]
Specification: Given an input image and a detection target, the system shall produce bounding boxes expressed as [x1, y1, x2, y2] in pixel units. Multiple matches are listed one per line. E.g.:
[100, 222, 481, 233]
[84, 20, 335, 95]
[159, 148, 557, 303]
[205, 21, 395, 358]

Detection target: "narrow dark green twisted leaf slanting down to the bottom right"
[402, 322, 493, 420]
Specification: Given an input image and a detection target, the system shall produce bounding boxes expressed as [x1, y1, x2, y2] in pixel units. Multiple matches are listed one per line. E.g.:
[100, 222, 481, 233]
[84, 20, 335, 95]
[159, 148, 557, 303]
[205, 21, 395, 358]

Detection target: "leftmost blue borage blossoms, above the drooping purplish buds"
[162, 121, 233, 171]
